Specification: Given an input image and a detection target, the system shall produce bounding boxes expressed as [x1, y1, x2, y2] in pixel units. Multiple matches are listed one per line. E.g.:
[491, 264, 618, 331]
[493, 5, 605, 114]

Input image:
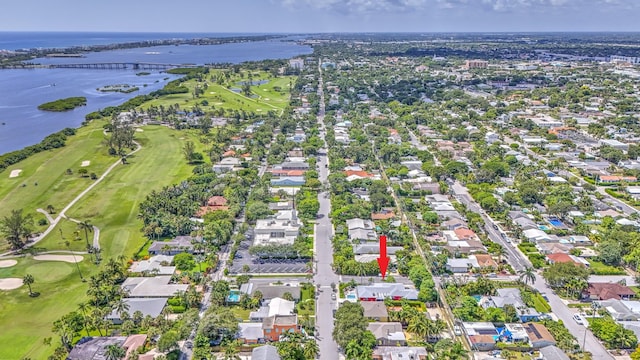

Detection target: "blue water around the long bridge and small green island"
[0, 33, 313, 154]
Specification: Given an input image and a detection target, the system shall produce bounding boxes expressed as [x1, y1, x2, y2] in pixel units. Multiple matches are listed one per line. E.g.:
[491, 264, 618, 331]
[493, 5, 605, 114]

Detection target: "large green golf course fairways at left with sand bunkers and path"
[0, 126, 202, 359]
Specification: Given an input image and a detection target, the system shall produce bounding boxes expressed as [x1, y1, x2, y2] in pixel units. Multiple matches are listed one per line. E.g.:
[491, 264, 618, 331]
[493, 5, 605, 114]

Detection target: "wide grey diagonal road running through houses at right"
[451, 181, 613, 360]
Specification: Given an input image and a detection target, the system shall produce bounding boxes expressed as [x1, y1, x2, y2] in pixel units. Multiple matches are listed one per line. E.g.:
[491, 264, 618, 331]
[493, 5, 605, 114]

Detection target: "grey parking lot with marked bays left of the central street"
[229, 240, 309, 274]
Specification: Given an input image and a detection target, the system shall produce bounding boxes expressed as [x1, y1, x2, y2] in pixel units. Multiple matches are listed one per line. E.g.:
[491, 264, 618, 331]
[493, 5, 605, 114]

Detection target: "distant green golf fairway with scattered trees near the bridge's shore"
[143, 70, 295, 114]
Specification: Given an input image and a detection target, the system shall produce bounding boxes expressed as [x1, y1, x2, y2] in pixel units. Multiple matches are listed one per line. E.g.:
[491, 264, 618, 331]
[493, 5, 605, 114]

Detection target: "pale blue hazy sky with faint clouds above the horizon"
[0, 0, 640, 33]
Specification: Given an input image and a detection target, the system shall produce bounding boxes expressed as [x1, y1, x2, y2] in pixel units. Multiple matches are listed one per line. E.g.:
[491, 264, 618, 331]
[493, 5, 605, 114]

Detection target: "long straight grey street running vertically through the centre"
[314, 68, 339, 360]
